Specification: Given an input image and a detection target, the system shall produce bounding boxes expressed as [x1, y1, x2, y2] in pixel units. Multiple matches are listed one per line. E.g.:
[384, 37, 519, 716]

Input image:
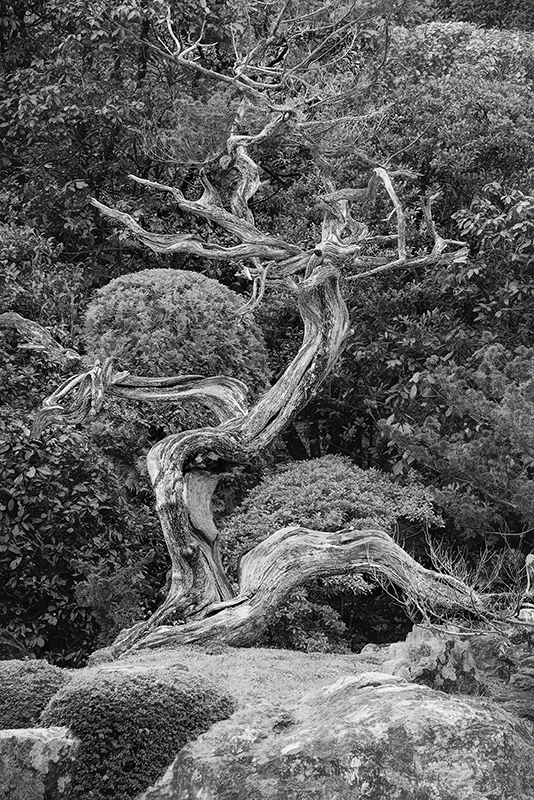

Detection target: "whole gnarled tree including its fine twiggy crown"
[0, 0, 486, 654]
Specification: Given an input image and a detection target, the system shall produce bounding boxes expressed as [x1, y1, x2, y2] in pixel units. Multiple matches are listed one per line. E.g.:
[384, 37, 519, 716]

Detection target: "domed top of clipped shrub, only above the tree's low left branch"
[85, 269, 268, 394]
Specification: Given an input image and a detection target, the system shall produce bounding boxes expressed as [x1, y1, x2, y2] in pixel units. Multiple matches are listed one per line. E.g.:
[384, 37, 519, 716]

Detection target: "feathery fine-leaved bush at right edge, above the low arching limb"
[388, 344, 534, 545]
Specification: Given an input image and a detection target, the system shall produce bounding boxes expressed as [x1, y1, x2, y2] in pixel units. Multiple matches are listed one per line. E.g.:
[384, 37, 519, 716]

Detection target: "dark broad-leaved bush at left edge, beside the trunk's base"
[0, 409, 166, 666]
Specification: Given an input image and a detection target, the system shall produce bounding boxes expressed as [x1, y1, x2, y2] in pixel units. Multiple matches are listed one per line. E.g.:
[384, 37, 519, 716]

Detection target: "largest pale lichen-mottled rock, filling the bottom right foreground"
[138, 673, 534, 800]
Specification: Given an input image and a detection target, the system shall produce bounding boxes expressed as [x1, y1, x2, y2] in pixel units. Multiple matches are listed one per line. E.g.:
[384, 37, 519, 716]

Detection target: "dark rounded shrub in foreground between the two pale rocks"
[41, 670, 235, 800]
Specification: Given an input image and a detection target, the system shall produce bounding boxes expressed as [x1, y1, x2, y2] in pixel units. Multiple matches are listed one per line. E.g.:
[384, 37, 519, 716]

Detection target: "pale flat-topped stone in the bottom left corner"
[0, 728, 78, 800]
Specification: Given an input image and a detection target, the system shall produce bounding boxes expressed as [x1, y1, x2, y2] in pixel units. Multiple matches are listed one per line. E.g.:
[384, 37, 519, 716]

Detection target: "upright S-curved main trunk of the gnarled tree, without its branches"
[113, 256, 354, 648]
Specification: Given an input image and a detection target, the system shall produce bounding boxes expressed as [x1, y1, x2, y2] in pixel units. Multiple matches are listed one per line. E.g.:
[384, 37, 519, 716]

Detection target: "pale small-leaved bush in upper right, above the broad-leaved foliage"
[371, 22, 534, 214]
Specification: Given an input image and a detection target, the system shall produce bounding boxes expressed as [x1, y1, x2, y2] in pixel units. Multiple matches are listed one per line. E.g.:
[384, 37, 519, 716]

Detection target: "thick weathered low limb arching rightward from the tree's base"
[112, 527, 483, 655]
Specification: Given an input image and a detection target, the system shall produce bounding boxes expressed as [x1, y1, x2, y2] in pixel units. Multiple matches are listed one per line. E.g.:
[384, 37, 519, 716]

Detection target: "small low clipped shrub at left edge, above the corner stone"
[0, 660, 71, 728]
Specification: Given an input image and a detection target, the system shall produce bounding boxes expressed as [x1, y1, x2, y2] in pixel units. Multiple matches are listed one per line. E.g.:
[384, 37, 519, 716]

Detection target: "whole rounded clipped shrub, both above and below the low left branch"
[85, 269, 269, 490]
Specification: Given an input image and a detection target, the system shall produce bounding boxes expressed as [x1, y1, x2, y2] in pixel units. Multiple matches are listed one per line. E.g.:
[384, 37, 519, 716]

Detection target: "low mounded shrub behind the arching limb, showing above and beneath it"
[222, 455, 441, 652]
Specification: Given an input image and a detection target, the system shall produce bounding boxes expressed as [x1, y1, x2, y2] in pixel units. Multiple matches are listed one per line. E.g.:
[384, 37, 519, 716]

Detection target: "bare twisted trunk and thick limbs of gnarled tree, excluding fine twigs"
[0, 4, 478, 655]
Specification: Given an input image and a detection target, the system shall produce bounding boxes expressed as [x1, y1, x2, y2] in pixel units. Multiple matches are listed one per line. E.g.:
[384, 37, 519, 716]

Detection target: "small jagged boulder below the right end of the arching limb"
[381, 625, 486, 695]
